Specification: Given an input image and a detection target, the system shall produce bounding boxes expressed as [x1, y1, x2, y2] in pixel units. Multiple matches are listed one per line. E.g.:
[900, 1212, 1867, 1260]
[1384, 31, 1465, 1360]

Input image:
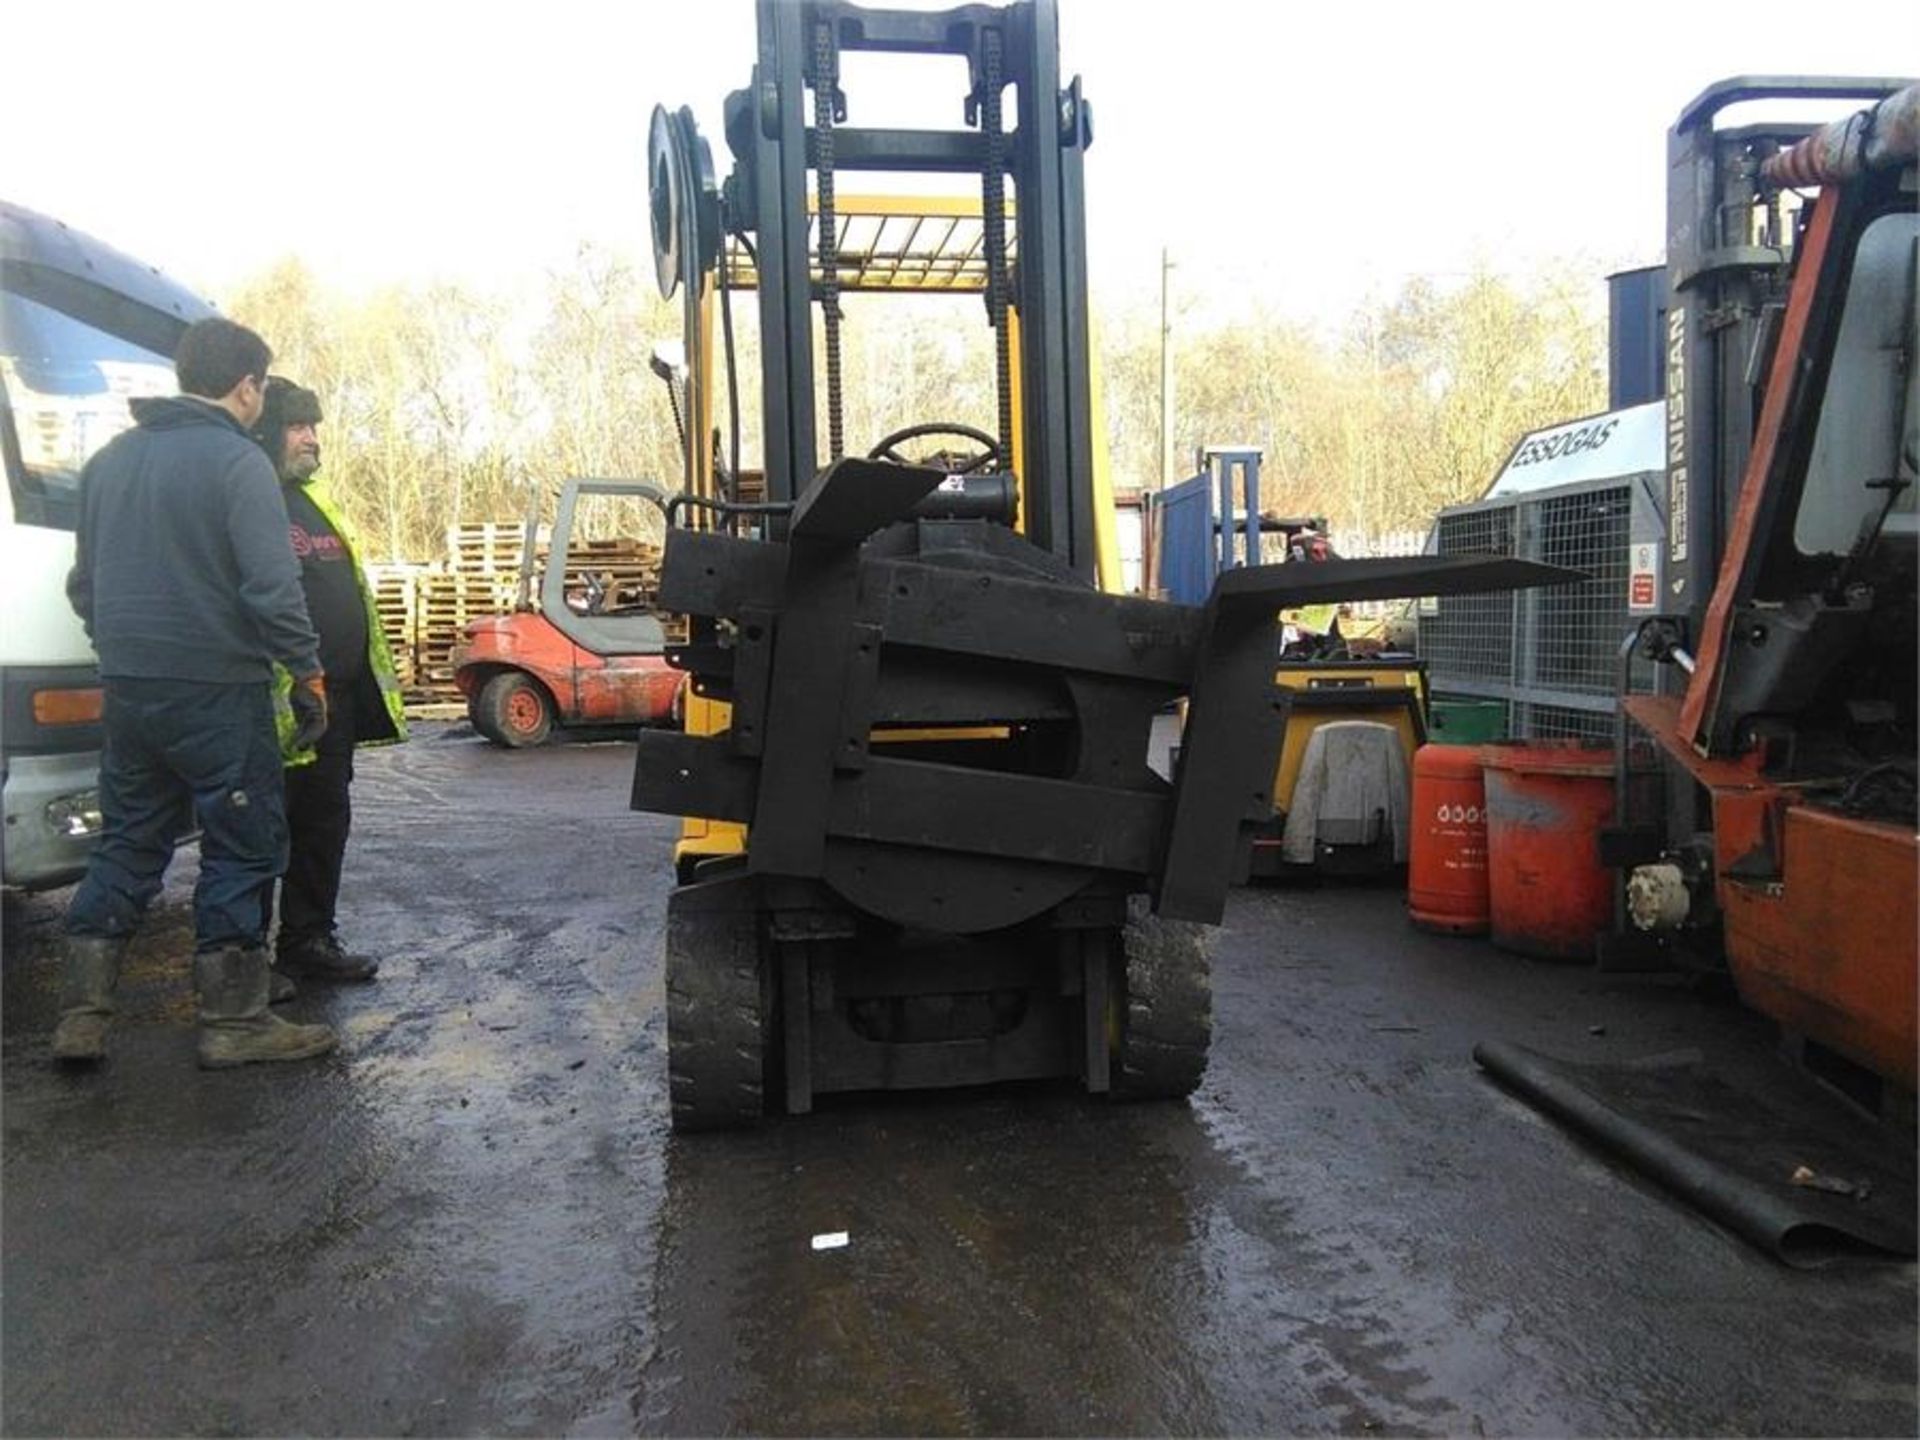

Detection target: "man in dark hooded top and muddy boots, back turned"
[54, 319, 336, 1068]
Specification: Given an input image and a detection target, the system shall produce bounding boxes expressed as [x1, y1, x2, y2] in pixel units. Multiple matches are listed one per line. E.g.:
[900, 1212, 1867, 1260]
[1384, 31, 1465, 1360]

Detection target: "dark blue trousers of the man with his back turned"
[67, 678, 286, 950]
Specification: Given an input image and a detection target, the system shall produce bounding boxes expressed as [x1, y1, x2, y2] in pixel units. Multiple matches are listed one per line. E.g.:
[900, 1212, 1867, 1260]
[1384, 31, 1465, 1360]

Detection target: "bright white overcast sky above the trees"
[0, 0, 1920, 321]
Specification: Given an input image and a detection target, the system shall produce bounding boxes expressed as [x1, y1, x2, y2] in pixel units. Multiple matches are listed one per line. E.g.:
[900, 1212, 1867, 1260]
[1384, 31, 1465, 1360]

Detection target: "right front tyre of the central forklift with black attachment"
[1112, 900, 1213, 1100]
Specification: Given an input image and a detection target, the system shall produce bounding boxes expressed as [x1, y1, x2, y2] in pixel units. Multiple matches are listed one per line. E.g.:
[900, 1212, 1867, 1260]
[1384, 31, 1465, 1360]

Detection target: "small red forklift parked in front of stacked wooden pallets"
[453, 480, 684, 749]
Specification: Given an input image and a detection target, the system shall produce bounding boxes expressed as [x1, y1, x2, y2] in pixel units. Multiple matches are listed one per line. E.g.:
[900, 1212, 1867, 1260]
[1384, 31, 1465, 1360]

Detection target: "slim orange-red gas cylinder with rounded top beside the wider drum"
[1407, 745, 1486, 935]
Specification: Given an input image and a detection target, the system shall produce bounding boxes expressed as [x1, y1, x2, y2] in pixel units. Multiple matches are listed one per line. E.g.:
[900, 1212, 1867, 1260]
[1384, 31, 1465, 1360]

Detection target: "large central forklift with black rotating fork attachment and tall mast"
[632, 0, 1561, 1129]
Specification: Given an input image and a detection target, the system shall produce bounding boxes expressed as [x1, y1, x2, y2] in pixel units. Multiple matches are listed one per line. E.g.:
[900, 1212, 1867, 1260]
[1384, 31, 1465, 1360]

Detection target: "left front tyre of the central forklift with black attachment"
[666, 893, 774, 1131]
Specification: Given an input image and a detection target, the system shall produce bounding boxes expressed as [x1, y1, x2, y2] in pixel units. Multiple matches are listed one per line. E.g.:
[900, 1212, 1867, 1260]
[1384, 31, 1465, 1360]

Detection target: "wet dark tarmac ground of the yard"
[0, 728, 1920, 1436]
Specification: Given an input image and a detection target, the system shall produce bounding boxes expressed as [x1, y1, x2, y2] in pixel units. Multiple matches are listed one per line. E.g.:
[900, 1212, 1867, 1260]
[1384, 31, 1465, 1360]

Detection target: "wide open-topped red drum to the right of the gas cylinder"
[1482, 741, 1613, 960]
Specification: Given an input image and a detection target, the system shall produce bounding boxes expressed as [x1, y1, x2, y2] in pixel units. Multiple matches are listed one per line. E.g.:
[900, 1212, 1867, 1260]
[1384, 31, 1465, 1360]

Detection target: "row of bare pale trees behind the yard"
[230, 248, 1605, 559]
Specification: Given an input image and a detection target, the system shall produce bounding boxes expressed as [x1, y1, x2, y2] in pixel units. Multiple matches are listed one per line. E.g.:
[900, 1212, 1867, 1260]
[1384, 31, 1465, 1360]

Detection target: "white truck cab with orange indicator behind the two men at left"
[0, 202, 213, 889]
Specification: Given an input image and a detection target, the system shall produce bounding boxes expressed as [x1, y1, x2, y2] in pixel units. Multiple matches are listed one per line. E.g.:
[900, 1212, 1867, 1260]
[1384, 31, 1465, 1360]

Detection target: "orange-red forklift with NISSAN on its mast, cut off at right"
[1601, 79, 1920, 1117]
